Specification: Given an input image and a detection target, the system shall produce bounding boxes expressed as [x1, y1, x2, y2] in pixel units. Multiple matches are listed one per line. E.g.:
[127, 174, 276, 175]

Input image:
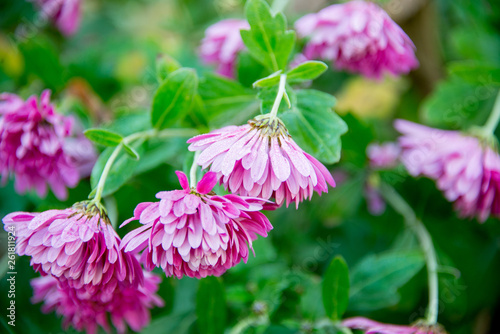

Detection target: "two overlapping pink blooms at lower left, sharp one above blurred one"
[3, 202, 162, 333]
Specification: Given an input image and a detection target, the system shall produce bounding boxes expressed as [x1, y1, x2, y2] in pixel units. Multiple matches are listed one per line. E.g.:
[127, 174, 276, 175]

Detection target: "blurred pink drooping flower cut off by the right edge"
[394, 120, 500, 221]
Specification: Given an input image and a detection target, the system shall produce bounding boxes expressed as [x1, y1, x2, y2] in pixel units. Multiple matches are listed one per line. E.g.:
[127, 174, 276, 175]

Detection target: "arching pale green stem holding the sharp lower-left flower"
[92, 129, 198, 204]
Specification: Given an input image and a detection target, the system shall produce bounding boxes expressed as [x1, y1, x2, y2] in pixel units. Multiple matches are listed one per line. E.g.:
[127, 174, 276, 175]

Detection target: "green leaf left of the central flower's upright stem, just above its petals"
[199, 75, 259, 127]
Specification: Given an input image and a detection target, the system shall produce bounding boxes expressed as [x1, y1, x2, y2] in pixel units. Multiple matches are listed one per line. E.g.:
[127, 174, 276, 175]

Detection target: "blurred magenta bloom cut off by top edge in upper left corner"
[32, 0, 81, 36]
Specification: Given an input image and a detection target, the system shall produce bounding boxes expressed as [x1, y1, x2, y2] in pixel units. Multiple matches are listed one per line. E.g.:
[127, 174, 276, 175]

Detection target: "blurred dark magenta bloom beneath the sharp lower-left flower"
[31, 273, 163, 334]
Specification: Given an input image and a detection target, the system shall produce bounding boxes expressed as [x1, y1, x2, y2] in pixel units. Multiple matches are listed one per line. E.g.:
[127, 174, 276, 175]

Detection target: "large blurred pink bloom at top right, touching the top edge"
[295, 1, 418, 78]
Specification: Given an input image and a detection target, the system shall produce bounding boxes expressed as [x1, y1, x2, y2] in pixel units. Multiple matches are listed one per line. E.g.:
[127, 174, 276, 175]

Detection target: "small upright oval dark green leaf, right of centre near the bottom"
[322, 256, 349, 321]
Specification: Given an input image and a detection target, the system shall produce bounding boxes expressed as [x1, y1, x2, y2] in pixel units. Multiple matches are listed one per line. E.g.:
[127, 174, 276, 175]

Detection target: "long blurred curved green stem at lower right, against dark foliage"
[380, 183, 439, 325]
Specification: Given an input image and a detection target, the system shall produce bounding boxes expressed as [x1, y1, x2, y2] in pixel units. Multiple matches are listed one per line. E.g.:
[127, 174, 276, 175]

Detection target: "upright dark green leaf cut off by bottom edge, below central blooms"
[196, 276, 226, 334]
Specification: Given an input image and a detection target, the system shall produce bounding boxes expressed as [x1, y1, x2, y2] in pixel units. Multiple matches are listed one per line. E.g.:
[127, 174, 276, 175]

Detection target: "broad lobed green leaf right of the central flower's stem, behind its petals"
[279, 89, 347, 164]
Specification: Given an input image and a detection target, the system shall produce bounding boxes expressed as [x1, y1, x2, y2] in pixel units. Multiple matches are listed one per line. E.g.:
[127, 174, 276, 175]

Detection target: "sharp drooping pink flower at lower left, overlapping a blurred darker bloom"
[3, 202, 143, 291]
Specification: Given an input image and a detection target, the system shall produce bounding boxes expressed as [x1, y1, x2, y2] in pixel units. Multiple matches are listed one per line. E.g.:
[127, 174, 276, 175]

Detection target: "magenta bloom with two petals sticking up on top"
[122, 172, 272, 278]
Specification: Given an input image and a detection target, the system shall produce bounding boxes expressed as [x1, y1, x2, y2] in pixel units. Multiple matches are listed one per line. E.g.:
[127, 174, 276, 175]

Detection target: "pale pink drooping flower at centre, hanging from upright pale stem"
[188, 115, 335, 207]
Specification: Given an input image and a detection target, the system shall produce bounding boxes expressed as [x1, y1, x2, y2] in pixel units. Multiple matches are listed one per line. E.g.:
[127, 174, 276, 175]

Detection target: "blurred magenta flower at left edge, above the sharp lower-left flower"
[0, 90, 96, 200]
